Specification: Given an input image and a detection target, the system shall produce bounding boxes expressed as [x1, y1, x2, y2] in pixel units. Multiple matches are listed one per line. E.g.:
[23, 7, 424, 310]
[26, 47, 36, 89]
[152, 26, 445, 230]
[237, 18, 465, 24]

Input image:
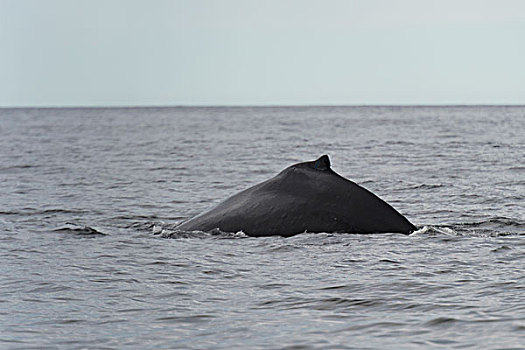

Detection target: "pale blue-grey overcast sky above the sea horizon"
[0, 0, 525, 107]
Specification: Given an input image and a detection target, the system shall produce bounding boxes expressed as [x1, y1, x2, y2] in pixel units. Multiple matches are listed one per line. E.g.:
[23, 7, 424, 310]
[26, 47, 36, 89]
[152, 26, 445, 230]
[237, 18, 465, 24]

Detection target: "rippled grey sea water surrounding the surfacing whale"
[0, 107, 525, 349]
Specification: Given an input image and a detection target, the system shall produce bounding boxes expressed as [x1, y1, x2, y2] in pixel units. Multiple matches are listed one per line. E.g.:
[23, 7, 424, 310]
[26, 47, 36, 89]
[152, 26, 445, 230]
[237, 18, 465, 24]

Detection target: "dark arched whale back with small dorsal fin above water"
[176, 155, 416, 237]
